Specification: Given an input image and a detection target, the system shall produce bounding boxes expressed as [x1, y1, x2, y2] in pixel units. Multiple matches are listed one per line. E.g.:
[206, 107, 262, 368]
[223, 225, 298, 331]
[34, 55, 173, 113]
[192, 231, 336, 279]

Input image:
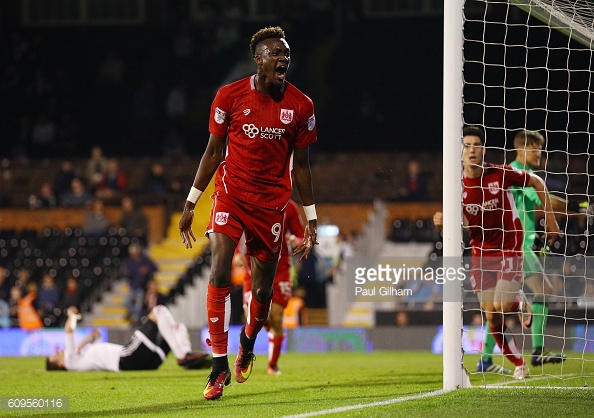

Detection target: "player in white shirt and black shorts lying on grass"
[46, 305, 212, 372]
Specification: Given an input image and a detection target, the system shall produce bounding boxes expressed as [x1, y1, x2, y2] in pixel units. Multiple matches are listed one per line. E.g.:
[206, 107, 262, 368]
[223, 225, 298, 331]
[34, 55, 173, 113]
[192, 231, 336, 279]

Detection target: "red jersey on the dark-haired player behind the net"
[462, 163, 530, 255]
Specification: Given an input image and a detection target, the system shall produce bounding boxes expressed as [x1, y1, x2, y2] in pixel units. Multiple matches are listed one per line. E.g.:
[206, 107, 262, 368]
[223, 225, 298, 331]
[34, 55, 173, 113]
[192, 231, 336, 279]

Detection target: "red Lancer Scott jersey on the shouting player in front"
[209, 75, 317, 210]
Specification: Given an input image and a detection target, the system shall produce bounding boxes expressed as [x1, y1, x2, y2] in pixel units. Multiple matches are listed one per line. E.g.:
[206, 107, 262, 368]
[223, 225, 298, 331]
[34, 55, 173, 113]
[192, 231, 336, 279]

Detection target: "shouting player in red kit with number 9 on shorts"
[179, 27, 317, 399]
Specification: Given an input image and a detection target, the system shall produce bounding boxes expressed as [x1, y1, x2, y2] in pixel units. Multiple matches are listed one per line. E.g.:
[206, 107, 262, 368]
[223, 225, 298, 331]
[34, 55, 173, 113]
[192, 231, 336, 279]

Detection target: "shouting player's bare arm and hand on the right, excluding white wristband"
[293, 147, 318, 261]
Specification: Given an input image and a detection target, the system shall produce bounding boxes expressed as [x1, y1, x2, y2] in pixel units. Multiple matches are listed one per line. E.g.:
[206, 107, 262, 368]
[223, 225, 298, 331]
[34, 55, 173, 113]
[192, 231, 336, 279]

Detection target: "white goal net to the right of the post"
[444, 0, 594, 387]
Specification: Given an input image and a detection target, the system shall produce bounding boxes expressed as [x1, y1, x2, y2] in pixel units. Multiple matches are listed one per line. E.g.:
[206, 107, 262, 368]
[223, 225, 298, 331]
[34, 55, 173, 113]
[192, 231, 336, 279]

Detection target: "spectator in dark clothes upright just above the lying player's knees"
[121, 244, 159, 323]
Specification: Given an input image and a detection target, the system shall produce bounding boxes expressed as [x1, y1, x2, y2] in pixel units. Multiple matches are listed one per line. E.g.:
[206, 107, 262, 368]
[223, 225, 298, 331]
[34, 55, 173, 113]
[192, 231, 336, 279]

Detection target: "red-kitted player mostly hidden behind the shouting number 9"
[243, 200, 305, 374]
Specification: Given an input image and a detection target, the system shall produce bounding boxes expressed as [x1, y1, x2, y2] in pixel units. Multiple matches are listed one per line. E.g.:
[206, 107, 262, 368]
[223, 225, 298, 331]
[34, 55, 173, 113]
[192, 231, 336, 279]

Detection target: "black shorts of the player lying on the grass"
[120, 320, 171, 370]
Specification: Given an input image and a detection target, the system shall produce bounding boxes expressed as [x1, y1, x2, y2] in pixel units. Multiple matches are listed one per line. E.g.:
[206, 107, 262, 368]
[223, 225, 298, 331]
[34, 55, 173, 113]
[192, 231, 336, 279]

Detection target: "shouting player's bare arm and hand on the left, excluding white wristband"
[179, 134, 225, 248]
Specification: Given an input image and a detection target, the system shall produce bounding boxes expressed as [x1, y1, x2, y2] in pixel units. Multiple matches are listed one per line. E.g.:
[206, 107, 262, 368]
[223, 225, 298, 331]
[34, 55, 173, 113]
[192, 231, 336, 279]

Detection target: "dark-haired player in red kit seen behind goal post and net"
[433, 126, 559, 379]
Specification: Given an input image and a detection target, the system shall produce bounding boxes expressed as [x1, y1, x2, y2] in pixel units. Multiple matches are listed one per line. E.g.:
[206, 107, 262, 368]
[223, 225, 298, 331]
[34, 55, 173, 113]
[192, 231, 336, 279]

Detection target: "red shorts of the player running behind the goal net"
[470, 253, 523, 292]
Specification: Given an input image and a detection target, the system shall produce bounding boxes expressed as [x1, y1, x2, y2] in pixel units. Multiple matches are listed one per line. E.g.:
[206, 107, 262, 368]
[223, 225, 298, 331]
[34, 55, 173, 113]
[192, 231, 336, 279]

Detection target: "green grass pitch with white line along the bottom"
[0, 351, 594, 418]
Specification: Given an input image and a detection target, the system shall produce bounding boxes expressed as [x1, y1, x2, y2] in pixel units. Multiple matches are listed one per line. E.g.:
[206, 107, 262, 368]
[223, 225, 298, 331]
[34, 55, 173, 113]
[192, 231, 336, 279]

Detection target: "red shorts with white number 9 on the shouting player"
[206, 195, 284, 263]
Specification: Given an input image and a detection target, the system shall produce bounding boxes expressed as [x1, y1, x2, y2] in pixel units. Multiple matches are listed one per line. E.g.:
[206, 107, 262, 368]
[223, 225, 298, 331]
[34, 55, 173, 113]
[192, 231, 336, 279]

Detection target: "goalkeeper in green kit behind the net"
[477, 129, 567, 373]
